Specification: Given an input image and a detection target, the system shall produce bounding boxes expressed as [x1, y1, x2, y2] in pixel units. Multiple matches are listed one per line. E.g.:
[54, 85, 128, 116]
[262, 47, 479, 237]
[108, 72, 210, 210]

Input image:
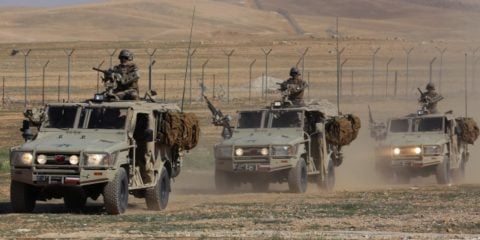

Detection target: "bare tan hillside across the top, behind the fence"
[0, 0, 480, 43]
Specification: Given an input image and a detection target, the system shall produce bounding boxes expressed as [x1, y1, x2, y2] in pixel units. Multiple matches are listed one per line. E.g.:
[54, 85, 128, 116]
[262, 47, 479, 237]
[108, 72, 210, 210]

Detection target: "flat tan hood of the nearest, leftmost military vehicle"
[21, 132, 126, 152]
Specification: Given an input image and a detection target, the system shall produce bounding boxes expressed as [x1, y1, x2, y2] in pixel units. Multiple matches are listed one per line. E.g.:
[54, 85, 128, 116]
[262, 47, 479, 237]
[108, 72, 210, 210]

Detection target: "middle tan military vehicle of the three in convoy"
[206, 96, 360, 193]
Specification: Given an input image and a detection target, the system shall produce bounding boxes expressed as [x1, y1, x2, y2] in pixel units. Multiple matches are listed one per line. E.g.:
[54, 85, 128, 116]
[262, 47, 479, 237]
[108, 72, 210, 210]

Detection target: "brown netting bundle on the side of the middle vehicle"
[325, 114, 361, 146]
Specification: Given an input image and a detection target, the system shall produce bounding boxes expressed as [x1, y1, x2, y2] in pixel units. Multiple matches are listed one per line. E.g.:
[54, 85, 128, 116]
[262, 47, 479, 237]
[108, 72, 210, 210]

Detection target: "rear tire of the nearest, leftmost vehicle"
[145, 167, 170, 211]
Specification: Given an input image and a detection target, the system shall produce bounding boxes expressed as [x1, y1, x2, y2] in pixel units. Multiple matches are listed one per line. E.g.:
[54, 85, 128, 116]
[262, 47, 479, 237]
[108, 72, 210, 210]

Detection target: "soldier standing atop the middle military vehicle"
[280, 67, 308, 105]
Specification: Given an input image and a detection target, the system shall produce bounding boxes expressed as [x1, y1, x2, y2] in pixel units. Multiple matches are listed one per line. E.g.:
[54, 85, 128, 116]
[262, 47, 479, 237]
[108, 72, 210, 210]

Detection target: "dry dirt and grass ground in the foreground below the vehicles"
[0, 172, 480, 239]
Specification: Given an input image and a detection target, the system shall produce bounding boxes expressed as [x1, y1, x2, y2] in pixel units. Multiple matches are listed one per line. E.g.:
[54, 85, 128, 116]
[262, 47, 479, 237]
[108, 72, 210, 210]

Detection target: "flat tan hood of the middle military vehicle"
[222, 129, 304, 146]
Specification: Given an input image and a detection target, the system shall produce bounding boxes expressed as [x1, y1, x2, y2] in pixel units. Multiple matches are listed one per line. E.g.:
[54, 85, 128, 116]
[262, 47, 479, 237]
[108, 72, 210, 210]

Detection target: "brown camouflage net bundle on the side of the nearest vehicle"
[158, 112, 200, 150]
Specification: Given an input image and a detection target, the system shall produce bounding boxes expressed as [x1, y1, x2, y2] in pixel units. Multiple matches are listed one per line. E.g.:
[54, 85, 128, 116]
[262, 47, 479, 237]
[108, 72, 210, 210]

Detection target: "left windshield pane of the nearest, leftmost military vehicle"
[44, 106, 78, 128]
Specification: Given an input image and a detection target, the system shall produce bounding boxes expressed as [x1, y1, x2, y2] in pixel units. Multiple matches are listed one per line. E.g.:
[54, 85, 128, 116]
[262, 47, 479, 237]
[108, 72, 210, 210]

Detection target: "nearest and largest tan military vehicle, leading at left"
[10, 70, 200, 214]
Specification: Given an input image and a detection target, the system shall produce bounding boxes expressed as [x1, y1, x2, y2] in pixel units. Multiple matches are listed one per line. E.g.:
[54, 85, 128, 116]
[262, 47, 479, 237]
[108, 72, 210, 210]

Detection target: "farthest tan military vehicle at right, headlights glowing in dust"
[370, 95, 478, 184]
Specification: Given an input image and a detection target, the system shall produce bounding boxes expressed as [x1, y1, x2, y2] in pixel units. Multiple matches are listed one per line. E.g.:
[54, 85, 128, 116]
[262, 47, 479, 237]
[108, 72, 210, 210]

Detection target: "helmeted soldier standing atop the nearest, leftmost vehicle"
[113, 49, 140, 100]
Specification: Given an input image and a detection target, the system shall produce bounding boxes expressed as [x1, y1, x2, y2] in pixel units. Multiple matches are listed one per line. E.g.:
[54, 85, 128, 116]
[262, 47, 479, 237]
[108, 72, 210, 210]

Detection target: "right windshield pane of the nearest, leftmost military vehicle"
[86, 108, 127, 129]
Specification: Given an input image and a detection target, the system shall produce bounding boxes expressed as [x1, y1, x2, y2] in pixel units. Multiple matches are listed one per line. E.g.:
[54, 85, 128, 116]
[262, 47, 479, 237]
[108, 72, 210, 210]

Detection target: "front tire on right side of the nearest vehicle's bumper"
[103, 167, 128, 215]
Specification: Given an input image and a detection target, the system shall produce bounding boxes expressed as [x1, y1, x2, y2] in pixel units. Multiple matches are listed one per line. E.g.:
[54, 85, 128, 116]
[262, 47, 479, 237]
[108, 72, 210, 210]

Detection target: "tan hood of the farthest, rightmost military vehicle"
[381, 133, 448, 146]
